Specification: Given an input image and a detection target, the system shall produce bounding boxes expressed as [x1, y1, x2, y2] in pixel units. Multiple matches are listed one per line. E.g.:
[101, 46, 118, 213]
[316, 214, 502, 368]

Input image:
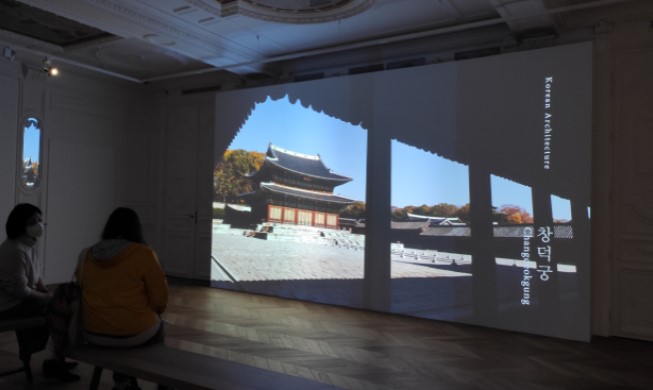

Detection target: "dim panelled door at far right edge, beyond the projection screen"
[610, 48, 653, 341]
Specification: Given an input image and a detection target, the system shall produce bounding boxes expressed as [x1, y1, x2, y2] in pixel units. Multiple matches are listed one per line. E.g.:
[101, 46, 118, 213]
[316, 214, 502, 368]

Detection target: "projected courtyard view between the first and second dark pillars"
[390, 140, 472, 318]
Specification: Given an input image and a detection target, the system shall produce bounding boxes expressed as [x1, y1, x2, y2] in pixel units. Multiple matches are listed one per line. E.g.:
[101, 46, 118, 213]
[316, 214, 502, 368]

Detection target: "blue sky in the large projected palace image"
[229, 98, 570, 219]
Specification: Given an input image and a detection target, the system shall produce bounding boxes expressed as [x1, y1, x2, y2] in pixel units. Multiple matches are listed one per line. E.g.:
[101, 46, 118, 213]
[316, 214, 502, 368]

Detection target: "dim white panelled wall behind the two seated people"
[0, 60, 159, 283]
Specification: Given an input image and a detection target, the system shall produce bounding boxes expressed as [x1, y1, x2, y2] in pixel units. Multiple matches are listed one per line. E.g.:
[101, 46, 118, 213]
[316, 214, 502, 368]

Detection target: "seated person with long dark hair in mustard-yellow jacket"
[77, 207, 168, 389]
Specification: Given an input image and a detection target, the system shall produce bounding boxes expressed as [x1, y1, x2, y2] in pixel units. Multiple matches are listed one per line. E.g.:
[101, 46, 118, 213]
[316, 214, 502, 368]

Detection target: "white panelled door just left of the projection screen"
[159, 100, 213, 280]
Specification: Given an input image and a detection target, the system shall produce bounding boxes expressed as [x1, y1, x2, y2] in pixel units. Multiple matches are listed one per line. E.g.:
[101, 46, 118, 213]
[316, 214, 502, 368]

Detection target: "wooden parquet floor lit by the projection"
[0, 281, 653, 390]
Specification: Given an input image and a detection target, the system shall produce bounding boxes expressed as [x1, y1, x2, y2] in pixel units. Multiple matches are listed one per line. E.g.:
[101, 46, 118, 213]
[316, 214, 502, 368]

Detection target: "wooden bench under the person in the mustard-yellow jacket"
[68, 344, 335, 390]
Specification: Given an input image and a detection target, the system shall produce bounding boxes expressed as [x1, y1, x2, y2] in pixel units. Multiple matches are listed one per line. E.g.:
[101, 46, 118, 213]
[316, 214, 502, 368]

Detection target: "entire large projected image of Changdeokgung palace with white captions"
[212, 44, 592, 340]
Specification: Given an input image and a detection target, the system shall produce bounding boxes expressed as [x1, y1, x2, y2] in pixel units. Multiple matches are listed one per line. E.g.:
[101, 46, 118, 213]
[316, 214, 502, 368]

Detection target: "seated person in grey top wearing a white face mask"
[0, 203, 79, 382]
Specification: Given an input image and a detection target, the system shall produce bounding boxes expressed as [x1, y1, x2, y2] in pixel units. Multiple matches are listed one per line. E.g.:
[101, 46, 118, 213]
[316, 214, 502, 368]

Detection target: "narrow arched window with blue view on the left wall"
[19, 116, 43, 189]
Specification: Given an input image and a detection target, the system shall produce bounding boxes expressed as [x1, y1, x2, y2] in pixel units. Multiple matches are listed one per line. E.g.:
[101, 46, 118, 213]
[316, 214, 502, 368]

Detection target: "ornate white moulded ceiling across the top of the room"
[0, 0, 653, 82]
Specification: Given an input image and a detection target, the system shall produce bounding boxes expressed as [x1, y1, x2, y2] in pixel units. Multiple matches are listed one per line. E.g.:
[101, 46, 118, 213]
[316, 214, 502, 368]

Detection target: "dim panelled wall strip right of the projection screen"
[592, 20, 653, 341]
